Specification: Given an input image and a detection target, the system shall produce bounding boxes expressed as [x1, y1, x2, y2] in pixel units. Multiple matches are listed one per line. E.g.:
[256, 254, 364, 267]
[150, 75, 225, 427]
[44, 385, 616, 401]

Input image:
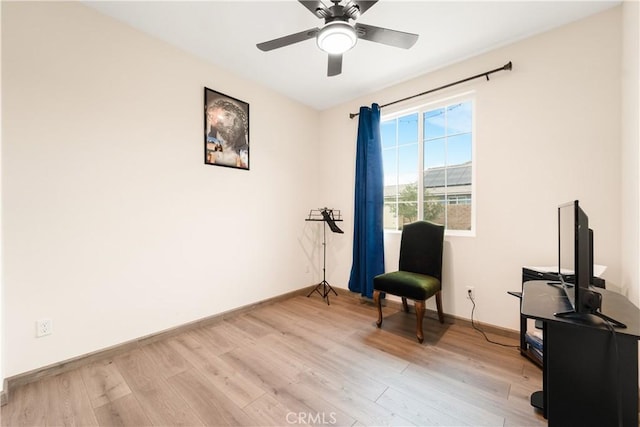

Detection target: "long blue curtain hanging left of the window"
[349, 104, 384, 298]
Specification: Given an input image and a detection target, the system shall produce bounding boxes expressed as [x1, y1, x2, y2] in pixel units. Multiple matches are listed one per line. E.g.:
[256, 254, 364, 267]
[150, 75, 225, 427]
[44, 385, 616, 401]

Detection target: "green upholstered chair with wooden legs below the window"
[373, 221, 444, 343]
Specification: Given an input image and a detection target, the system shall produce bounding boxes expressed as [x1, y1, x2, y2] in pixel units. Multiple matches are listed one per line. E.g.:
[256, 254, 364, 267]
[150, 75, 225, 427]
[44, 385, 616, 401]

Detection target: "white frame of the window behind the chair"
[380, 91, 478, 237]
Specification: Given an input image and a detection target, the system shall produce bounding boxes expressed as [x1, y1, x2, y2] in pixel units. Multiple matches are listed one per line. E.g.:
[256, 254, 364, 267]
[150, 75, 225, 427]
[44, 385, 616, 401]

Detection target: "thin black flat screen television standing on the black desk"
[555, 200, 626, 328]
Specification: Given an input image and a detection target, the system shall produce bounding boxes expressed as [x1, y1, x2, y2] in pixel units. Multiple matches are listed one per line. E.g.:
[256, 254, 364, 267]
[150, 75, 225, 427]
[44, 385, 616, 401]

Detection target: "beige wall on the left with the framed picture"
[2, 2, 321, 377]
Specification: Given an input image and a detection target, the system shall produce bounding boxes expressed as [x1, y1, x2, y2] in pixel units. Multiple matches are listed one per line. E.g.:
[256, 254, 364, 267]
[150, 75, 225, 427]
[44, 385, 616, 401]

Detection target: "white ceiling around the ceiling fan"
[85, 0, 620, 110]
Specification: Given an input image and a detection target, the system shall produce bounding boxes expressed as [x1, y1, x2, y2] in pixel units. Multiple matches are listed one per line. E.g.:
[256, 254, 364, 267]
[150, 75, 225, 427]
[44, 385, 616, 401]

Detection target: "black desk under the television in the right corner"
[521, 280, 640, 427]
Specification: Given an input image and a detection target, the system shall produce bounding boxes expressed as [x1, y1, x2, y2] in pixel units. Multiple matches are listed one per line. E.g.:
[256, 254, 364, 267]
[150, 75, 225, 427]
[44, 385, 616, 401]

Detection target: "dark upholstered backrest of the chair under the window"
[399, 221, 444, 280]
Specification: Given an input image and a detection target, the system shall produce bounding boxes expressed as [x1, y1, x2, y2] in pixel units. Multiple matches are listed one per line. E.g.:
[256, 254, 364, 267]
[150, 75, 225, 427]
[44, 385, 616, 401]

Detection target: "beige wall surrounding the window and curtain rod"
[321, 7, 624, 329]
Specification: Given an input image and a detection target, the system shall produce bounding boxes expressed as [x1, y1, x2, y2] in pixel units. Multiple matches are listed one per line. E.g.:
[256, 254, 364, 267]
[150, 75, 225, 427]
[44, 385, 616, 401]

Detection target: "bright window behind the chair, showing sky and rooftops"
[380, 98, 474, 235]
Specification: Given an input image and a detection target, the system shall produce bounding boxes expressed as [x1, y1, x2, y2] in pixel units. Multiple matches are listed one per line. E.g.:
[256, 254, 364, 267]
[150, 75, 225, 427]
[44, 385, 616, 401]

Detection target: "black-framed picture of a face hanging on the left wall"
[204, 87, 249, 170]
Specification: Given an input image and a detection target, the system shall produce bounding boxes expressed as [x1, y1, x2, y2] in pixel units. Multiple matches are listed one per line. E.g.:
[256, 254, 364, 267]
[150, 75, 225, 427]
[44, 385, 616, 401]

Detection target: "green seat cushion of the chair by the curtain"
[373, 271, 440, 300]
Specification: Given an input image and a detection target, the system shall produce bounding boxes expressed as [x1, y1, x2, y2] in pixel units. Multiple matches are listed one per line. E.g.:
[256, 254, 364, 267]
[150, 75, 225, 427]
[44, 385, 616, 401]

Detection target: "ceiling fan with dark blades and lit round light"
[256, 0, 418, 76]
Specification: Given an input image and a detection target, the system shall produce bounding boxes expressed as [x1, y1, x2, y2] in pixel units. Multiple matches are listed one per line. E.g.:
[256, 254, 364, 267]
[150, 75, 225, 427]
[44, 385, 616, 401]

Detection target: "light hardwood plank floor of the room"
[1, 291, 546, 426]
